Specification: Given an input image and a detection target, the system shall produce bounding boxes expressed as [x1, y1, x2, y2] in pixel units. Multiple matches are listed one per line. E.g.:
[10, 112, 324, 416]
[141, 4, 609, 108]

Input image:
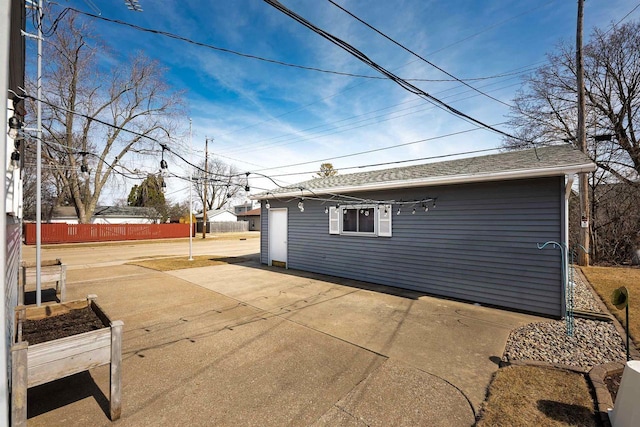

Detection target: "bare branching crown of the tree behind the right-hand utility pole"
[505, 21, 640, 186]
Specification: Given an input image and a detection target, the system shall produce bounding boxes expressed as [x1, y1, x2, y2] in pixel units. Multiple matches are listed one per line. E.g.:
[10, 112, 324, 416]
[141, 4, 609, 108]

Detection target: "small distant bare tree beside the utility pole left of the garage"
[194, 158, 247, 210]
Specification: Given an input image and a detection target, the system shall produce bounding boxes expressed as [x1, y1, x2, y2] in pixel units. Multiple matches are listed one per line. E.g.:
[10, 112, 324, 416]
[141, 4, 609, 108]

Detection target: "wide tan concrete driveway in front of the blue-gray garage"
[22, 242, 539, 426]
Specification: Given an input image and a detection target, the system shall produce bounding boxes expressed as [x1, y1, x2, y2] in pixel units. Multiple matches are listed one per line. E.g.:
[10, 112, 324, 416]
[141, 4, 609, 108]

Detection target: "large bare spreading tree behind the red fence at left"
[31, 13, 186, 223]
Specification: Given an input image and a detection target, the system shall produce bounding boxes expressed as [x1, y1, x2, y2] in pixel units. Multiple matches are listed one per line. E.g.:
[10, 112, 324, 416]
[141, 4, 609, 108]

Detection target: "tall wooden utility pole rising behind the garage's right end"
[576, 0, 591, 266]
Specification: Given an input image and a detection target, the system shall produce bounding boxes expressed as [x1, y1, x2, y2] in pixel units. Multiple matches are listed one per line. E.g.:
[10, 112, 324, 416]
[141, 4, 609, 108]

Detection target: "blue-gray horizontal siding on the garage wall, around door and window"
[261, 177, 564, 317]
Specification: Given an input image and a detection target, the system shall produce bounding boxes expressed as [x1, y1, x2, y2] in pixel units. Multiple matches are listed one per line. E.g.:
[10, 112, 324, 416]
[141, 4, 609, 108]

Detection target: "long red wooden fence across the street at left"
[23, 223, 189, 245]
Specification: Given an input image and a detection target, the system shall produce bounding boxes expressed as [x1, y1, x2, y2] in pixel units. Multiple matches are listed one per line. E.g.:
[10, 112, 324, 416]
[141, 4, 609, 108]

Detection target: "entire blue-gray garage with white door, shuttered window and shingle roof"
[254, 146, 595, 317]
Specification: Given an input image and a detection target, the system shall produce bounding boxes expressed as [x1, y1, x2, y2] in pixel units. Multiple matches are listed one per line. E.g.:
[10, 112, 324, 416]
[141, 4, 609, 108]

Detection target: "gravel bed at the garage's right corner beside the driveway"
[503, 268, 626, 369]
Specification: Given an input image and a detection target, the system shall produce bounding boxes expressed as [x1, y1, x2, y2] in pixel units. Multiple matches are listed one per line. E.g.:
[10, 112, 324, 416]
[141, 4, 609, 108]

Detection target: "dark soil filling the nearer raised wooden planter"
[22, 307, 105, 345]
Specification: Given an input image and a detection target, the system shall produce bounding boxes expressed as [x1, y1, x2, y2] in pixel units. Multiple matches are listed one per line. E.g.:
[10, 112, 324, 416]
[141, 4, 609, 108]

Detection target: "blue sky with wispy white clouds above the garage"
[45, 0, 640, 204]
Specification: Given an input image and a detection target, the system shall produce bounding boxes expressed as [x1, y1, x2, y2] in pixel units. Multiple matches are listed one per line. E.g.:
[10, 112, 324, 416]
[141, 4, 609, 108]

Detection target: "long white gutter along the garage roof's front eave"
[250, 162, 596, 200]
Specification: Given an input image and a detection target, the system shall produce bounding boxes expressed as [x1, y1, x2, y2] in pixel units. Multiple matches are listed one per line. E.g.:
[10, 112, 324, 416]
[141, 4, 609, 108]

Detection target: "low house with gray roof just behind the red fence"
[49, 206, 158, 224]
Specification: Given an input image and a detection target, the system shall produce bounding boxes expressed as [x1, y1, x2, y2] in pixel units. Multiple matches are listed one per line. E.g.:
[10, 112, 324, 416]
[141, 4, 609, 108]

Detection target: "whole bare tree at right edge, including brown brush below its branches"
[504, 21, 640, 262]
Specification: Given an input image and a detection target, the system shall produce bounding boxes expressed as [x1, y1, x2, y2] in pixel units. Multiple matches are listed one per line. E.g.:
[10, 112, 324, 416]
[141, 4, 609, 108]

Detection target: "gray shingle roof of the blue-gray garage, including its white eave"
[252, 145, 595, 199]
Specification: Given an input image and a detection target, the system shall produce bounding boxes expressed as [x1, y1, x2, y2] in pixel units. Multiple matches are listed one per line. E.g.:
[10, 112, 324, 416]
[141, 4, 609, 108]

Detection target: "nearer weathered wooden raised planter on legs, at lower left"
[11, 295, 124, 426]
